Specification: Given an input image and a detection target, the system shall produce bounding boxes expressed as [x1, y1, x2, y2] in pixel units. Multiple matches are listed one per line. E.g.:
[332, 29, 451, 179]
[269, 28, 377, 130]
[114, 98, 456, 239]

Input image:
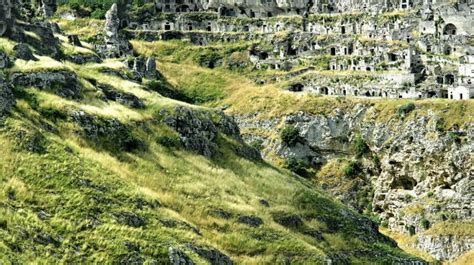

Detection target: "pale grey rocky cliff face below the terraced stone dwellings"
[239, 104, 474, 260]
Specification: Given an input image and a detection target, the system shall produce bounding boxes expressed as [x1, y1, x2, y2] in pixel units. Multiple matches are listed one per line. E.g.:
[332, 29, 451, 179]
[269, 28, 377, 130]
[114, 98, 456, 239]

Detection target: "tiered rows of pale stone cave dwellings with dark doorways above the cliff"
[123, 0, 474, 99]
